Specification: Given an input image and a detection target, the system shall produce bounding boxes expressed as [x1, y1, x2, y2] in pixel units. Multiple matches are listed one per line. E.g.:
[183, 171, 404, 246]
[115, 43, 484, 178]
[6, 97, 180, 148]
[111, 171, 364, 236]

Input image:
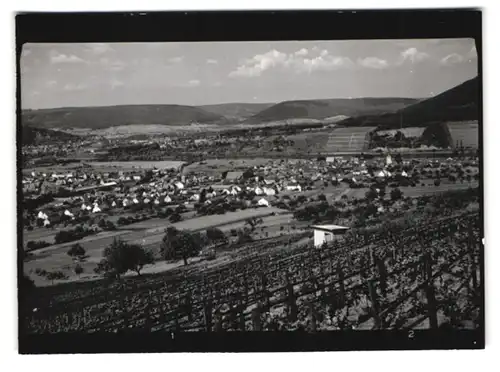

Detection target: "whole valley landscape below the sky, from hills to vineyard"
[18, 37, 482, 334]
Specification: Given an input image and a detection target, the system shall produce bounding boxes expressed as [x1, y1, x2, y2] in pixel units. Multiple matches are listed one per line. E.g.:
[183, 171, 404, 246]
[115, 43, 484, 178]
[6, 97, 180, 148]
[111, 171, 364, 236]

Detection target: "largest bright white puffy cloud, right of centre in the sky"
[229, 48, 353, 78]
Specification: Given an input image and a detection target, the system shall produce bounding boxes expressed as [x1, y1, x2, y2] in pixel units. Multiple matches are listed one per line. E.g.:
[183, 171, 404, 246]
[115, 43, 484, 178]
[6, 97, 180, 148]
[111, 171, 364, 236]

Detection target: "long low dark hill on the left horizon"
[22, 105, 226, 129]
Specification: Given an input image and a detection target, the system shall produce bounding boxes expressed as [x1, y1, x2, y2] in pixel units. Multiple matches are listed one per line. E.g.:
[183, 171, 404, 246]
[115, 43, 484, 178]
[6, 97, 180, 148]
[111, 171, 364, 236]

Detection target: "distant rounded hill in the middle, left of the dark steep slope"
[245, 98, 417, 124]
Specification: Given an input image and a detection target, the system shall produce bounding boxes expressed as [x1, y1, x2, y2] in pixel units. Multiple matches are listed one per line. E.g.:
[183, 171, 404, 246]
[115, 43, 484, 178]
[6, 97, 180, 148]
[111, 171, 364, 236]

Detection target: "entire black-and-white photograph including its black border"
[17, 10, 485, 353]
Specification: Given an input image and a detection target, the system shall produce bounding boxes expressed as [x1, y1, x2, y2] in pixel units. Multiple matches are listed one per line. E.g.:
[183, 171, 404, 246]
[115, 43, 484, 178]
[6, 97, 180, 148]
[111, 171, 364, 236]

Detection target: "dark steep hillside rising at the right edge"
[339, 77, 480, 129]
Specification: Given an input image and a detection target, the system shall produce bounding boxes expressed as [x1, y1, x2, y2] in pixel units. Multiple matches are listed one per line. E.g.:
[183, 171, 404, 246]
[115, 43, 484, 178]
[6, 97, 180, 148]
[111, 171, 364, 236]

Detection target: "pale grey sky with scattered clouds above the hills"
[21, 39, 477, 109]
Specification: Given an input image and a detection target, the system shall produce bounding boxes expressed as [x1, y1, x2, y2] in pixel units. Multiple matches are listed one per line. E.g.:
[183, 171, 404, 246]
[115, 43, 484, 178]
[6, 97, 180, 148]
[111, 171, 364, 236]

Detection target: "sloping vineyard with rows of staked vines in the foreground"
[23, 213, 482, 333]
